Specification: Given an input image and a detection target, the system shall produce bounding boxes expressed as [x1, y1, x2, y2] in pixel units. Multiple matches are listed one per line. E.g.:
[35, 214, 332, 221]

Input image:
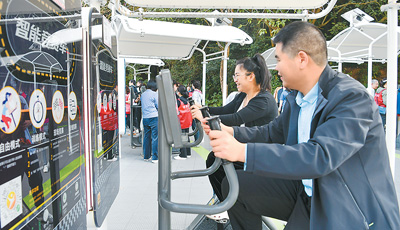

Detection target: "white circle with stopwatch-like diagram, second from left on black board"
[29, 89, 47, 129]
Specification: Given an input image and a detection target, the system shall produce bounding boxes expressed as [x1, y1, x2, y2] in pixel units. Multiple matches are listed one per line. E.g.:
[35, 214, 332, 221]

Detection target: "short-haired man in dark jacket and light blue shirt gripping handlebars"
[205, 22, 400, 230]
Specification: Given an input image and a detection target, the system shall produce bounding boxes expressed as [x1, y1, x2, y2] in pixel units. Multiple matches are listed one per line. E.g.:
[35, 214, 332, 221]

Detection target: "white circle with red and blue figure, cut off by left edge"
[0, 86, 21, 134]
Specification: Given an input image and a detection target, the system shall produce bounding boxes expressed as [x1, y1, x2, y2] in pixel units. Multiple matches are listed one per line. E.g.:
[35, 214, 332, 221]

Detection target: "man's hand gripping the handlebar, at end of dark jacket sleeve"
[208, 130, 246, 162]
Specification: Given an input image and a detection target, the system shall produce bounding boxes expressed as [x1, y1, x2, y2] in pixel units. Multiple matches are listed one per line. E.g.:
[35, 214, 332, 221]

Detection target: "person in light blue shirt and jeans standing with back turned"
[140, 80, 158, 163]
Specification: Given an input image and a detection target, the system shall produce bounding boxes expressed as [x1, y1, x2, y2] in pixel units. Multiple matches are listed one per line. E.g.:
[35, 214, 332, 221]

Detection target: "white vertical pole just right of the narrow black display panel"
[117, 58, 126, 135]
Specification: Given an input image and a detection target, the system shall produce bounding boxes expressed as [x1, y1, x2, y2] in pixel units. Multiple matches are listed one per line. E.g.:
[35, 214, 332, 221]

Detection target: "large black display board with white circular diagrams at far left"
[0, 0, 86, 230]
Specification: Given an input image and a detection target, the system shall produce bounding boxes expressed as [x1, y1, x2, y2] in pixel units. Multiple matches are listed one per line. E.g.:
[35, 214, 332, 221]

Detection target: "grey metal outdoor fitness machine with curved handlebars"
[156, 70, 239, 230]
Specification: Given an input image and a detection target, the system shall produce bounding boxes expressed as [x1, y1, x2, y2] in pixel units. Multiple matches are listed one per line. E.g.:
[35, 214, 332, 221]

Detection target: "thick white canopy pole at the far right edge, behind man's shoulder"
[381, 0, 398, 177]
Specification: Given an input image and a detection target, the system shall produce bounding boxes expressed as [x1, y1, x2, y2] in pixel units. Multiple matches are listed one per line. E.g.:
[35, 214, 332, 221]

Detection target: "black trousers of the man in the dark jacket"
[222, 170, 311, 230]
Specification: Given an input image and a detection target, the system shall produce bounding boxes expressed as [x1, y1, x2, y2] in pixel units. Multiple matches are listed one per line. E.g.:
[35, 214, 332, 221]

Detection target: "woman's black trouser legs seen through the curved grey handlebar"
[206, 152, 244, 202]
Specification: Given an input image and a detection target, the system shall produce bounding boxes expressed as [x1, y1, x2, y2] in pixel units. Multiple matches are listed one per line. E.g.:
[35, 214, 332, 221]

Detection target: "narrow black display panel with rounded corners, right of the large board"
[90, 40, 120, 227]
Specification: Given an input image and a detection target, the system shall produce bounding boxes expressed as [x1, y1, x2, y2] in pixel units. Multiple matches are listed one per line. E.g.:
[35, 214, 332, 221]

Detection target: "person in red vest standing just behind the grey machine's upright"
[174, 85, 192, 160]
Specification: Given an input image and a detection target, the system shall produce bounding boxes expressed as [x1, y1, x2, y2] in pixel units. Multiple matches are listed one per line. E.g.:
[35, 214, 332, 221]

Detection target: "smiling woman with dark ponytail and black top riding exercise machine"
[192, 54, 278, 220]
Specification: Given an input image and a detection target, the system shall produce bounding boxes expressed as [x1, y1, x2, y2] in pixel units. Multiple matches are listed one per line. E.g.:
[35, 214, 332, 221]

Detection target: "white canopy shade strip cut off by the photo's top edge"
[126, 0, 328, 9]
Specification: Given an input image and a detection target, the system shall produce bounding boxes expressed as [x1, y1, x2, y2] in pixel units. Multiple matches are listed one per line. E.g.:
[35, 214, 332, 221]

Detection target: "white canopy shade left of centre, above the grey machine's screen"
[117, 16, 253, 59]
